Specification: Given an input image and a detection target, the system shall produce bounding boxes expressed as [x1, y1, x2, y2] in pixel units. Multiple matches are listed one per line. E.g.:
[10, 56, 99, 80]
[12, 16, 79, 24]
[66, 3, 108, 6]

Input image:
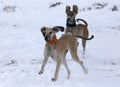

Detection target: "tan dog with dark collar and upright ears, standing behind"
[65, 5, 89, 54]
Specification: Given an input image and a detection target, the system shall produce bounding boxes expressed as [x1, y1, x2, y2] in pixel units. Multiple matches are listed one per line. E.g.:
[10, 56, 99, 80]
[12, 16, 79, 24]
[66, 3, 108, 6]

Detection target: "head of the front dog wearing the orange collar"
[41, 26, 64, 41]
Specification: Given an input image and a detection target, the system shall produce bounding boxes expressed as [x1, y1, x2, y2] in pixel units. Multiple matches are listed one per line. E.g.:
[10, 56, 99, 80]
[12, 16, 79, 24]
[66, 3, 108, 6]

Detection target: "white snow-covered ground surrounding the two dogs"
[0, 0, 120, 87]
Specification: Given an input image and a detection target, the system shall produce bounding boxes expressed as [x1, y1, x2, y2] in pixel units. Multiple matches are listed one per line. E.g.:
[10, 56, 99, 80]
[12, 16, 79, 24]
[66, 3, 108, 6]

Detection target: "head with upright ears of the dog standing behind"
[66, 5, 78, 21]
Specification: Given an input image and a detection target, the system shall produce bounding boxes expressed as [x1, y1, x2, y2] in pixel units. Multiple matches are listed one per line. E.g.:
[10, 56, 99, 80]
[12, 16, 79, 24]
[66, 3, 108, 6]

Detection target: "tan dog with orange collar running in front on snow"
[39, 26, 93, 81]
